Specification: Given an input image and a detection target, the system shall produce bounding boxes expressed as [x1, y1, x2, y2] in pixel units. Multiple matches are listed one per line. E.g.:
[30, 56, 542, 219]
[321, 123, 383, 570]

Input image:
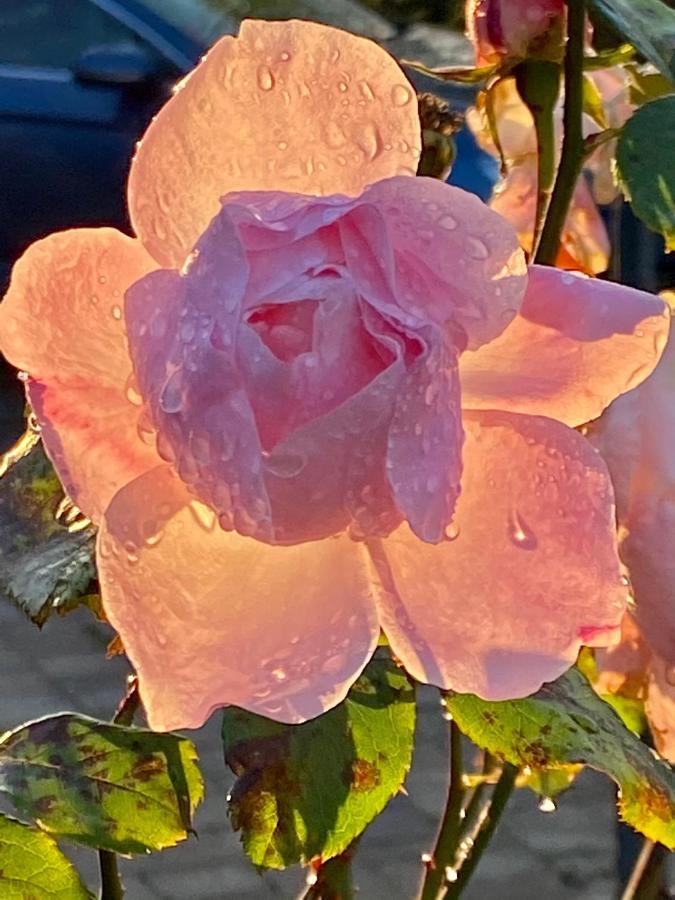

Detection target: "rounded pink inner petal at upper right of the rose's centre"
[352, 178, 526, 347]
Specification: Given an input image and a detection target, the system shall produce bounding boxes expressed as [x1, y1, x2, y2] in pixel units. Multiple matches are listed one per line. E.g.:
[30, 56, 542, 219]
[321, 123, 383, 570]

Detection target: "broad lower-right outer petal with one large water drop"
[375, 412, 626, 700]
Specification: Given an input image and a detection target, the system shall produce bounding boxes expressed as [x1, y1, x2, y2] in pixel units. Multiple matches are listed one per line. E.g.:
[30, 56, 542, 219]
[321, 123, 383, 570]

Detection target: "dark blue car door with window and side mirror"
[0, 0, 179, 290]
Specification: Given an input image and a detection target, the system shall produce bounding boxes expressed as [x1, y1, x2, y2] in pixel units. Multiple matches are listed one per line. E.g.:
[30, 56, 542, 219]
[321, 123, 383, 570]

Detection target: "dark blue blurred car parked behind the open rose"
[0, 0, 496, 288]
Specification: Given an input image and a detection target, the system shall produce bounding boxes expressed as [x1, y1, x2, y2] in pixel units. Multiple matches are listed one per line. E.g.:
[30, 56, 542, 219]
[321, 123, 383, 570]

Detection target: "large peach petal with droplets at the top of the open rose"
[129, 20, 420, 265]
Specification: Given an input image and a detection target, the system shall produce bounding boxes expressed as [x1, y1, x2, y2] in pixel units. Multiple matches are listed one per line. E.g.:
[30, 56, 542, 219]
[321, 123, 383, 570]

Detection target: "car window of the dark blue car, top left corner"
[0, 0, 149, 68]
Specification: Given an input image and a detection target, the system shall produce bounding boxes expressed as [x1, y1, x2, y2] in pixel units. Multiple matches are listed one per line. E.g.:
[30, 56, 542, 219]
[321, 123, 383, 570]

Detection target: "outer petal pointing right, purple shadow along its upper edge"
[459, 266, 669, 426]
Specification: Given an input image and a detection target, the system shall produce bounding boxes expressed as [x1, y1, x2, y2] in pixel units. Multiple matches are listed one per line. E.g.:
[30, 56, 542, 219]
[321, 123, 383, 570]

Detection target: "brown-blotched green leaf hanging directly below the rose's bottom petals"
[223, 656, 415, 869]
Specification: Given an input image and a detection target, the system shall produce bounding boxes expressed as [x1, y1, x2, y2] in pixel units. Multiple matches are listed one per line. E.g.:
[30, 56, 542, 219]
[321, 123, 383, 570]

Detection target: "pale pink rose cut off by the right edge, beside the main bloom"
[591, 308, 675, 762]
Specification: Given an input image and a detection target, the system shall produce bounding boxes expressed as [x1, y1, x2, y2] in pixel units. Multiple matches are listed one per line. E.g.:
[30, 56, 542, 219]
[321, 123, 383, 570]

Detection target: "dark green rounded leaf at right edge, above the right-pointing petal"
[616, 96, 675, 250]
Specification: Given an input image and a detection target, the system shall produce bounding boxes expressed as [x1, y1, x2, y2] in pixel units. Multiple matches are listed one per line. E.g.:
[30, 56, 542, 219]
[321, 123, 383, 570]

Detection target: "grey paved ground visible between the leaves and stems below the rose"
[0, 602, 628, 900]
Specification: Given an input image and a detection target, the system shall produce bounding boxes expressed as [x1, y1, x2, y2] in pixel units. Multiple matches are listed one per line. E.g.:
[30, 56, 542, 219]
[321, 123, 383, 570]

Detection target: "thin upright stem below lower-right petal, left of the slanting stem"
[420, 721, 464, 900]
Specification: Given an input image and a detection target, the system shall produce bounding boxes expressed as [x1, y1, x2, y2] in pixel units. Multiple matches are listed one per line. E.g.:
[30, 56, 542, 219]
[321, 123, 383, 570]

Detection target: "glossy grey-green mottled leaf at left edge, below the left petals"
[0, 444, 98, 625]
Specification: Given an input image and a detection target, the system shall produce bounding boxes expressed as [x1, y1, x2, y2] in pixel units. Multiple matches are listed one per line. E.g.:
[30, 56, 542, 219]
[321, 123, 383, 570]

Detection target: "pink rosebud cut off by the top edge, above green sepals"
[466, 0, 567, 66]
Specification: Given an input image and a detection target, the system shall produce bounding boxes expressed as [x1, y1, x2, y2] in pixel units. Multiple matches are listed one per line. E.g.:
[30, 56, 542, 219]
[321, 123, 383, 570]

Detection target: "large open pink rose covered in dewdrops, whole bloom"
[0, 21, 668, 729]
